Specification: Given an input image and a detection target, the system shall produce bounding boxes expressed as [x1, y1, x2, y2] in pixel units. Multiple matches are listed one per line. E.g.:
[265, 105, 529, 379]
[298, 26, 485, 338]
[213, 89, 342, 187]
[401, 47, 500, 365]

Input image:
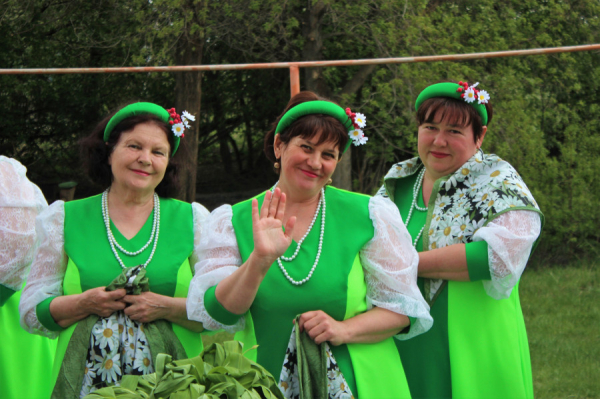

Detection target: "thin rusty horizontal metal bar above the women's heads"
[0, 44, 600, 75]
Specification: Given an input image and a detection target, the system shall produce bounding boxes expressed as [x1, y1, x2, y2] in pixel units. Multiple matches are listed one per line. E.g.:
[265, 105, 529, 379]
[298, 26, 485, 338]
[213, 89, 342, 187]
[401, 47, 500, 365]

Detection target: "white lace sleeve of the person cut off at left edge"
[0, 156, 48, 291]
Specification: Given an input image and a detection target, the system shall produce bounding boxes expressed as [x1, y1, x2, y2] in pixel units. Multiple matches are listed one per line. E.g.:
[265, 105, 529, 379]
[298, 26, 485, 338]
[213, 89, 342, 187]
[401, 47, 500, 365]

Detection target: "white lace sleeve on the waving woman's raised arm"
[187, 205, 244, 333]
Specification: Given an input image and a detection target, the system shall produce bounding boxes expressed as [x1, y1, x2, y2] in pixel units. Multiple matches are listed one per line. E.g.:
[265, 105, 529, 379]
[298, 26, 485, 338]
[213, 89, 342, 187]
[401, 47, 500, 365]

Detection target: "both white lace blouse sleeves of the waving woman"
[187, 197, 433, 339]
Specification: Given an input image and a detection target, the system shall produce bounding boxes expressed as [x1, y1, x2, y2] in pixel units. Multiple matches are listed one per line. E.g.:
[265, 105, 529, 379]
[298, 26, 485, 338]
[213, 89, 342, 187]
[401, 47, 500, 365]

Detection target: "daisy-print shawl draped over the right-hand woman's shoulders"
[378, 150, 541, 305]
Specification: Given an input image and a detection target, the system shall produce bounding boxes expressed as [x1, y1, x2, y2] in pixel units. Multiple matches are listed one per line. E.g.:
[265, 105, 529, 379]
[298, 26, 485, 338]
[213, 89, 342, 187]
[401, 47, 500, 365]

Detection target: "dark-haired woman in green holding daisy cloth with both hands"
[20, 103, 208, 398]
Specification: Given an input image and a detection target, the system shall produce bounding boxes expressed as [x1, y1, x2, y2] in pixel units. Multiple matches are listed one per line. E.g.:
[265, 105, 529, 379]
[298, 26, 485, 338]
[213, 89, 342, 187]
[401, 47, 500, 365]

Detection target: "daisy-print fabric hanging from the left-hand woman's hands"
[80, 268, 154, 397]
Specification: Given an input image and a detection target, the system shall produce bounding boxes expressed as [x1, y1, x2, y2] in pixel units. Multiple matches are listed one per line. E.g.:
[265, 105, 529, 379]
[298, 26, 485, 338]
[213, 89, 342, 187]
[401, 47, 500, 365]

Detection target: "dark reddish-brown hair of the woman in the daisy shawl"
[416, 97, 494, 142]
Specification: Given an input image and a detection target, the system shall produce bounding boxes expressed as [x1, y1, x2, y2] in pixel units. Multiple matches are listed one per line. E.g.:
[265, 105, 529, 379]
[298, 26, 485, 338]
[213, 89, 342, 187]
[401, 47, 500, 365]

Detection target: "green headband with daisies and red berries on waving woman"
[275, 100, 368, 152]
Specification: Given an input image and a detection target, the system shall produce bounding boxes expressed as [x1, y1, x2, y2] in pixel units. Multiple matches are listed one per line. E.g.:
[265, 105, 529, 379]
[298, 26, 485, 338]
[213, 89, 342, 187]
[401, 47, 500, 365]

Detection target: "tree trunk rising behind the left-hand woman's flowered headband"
[175, 0, 207, 202]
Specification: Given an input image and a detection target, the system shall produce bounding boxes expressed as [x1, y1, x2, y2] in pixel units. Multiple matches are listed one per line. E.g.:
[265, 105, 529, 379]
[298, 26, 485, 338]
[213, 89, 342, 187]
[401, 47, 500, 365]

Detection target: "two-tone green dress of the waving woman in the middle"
[188, 187, 430, 398]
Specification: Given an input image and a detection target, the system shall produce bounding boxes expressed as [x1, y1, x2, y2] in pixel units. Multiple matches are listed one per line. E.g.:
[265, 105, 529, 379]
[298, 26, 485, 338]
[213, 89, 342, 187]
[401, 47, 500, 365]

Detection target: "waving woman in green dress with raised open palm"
[188, 92, 432, 398]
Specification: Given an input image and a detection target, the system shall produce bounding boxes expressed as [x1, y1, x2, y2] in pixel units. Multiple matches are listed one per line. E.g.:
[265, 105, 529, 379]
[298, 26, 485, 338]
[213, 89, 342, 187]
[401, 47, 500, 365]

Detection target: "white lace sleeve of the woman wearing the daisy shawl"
[473, 210, 542, 299]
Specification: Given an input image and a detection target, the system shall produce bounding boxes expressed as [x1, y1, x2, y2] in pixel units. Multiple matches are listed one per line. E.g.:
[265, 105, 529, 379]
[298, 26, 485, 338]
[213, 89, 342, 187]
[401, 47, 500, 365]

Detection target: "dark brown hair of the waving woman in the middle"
[264, 91, 350, 162]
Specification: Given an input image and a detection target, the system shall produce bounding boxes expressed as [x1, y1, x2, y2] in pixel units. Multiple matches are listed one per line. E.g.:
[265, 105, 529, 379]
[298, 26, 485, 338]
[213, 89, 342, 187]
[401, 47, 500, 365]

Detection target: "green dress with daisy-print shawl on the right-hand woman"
[380, 152, 543, 399]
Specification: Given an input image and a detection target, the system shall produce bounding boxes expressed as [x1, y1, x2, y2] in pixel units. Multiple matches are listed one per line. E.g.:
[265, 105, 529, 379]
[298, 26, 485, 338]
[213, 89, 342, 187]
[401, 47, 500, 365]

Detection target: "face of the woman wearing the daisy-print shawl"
[418, 111, 487, 180]
